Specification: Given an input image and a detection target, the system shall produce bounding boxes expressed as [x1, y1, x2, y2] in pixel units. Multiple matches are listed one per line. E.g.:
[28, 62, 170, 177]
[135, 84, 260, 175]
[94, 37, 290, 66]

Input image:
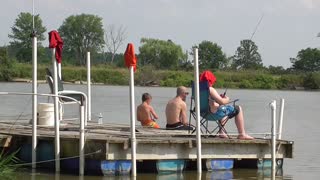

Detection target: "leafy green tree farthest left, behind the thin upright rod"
[8, 12, 47, 62]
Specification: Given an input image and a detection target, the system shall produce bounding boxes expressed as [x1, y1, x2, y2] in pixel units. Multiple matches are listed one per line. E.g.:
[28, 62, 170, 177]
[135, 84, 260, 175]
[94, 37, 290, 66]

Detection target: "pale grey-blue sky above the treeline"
[0, 0, 320, 68]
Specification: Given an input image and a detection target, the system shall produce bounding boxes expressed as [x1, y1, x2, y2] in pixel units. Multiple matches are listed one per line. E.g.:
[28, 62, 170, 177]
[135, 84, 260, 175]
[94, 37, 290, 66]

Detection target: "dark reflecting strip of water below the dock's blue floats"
[17, 168, 293, 180]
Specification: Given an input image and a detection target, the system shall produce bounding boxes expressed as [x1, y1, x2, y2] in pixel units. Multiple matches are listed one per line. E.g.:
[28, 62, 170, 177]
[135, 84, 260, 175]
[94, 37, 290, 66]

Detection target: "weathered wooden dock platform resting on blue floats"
[0, 121, 293, 173]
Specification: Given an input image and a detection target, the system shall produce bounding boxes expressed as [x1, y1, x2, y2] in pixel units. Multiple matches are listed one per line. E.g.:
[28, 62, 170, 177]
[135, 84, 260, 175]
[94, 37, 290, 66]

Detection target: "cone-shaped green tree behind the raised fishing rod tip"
[232, 39, 263, 69]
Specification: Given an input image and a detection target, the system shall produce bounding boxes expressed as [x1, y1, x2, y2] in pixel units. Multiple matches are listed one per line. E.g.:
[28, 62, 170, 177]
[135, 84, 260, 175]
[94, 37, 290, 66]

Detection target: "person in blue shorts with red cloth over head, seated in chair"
[200, 71, 254, 140]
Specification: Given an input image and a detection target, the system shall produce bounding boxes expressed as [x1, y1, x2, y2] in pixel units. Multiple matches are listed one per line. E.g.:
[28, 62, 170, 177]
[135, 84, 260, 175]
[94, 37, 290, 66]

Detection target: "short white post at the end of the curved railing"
[79, 104, 85, 176]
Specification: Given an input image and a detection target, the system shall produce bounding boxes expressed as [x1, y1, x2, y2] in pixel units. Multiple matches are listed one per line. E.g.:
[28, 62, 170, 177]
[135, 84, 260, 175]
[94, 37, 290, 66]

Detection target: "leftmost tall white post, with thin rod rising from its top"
[32, 34, 38, 169]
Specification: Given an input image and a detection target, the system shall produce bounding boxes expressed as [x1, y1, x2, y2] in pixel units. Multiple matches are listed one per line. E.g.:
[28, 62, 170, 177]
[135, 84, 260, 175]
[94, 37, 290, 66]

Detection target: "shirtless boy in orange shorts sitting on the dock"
[137, 93, 160, 129]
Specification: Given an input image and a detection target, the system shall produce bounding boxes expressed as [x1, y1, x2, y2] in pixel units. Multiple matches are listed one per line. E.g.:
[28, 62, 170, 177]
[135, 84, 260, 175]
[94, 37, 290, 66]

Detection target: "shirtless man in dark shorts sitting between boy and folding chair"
[166, 86, 193, 130]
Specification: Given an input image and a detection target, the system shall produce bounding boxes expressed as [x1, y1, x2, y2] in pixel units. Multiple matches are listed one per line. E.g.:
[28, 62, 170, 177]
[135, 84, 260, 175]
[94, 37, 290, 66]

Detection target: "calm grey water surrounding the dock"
[0, 83, 320, 180]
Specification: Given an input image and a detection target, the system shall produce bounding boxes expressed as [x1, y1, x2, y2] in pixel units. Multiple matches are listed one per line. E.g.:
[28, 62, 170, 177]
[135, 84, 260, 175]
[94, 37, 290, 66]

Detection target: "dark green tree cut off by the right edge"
[290, 48, 320, 72]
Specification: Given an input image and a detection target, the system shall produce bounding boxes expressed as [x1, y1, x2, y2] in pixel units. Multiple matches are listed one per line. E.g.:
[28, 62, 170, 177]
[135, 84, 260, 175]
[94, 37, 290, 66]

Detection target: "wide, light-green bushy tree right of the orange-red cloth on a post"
[139, 38, 186, 69]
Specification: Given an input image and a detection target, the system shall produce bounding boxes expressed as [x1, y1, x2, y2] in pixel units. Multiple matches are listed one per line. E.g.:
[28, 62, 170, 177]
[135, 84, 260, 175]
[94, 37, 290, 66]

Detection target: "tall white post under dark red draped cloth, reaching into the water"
[52, 48, 60, 172]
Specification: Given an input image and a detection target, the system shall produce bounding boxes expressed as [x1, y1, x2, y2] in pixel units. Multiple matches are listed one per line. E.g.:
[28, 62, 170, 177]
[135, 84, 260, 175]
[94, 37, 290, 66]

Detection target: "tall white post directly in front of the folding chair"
[193, 48, 202, 174]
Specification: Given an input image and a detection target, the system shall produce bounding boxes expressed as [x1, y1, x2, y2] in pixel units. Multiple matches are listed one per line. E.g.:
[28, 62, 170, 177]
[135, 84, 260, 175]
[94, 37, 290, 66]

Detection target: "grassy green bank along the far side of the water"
[0, 63, 320, 89]
